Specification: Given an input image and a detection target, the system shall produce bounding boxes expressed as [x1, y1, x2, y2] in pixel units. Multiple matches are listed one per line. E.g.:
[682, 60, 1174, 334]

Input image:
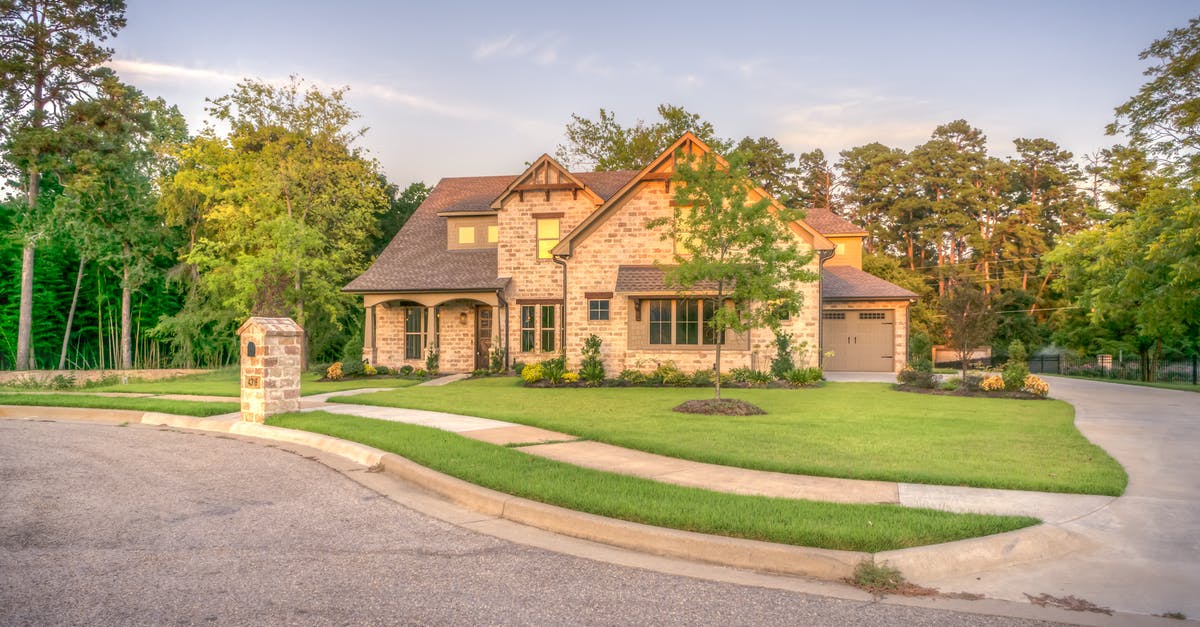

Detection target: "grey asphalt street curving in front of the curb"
[0, 420, 1060, 626]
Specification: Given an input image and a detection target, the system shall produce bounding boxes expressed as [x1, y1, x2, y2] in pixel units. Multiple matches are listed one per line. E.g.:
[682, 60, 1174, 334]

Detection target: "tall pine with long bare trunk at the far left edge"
[0, 0, 125, 370]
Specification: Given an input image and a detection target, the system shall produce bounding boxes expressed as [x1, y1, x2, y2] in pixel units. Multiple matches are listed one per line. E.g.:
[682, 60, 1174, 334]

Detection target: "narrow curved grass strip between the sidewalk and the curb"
[268, 410, 1038, 553]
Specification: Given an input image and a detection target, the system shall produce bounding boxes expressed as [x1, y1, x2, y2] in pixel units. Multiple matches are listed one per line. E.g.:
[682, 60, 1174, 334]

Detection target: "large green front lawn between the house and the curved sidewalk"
[338, 377, 1128, 495]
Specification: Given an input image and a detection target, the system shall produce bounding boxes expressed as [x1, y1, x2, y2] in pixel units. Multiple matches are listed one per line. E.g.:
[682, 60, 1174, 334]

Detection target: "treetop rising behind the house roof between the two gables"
[556, 105, 731, 172]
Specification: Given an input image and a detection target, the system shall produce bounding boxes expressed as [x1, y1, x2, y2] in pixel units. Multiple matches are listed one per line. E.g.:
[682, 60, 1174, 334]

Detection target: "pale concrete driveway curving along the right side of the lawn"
[934, 377, 1200, 619]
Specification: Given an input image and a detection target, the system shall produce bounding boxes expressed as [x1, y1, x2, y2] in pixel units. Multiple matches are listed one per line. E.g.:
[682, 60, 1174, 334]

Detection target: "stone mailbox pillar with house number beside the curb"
[238, 317, 304, 423]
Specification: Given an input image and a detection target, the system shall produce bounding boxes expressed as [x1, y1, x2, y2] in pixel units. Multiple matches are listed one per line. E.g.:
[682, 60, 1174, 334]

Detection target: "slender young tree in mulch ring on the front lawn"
[647, 151, 817, 401]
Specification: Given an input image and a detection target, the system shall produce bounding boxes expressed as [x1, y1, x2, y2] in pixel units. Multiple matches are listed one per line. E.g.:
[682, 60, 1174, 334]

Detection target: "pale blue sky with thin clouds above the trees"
[110, 0, 1200, 186]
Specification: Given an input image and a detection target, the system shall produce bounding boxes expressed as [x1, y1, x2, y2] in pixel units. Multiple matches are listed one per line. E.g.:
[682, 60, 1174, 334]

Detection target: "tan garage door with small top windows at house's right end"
[821, 309, 896, 372]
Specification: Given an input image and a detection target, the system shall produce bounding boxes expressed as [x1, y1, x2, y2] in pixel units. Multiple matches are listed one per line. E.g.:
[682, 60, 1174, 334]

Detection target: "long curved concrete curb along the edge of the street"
[0, 406, 1091, 584]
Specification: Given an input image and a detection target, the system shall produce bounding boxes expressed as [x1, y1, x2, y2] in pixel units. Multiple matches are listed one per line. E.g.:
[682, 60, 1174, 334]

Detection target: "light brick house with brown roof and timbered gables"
[344, 133, 916, 375]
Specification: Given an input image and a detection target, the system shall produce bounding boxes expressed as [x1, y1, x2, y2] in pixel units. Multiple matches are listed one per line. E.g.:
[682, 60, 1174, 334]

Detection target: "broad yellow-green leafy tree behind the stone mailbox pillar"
[163, 78, 388, 357]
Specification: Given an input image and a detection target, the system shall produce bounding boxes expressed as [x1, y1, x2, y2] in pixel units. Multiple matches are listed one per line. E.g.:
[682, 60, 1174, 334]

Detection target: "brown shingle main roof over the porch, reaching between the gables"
[343, 171, 636, 292]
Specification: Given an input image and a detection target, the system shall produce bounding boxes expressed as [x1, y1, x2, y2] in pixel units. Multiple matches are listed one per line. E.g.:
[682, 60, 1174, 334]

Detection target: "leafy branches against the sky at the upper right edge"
[1108, 17, 1200, 177]
